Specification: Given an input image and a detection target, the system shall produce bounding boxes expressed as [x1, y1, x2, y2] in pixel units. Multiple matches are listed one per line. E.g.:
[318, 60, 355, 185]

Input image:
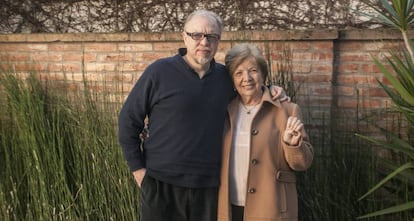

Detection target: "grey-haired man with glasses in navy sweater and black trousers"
[119, 10, 286, 221]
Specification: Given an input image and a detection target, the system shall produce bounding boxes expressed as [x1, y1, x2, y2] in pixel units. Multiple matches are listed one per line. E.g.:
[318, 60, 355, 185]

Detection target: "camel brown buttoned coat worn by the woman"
[218, 89, 313, 221]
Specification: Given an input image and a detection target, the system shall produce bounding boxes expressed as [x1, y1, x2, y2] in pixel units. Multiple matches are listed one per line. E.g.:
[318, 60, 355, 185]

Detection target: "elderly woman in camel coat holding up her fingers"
[218, 44, 313, 221]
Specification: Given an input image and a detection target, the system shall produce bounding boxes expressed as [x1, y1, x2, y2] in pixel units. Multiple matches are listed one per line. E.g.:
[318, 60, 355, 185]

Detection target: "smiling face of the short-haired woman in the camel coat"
[232, 58, 264, 97]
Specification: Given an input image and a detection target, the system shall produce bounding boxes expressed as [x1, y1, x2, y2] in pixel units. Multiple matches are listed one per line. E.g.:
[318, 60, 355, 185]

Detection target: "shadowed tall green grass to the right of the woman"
[297, 97, 413, 221]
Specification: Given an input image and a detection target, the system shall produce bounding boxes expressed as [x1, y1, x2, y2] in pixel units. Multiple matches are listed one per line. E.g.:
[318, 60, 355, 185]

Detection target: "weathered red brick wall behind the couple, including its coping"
[0, 30, 408, 144]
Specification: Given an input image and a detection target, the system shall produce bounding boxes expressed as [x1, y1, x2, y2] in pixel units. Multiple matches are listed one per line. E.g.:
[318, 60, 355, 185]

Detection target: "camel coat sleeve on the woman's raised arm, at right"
[282, 103, 313, 171]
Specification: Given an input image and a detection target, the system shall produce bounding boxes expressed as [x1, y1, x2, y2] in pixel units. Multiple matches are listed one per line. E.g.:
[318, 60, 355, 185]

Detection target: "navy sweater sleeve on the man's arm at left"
[118, 68, 157, 171]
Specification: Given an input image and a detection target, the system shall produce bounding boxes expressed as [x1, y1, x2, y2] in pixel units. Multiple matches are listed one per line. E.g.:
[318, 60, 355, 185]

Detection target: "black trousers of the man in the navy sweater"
[140, 175, 218, 221]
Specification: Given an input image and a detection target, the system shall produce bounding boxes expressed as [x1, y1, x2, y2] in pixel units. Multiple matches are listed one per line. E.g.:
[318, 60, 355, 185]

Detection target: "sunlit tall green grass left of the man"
[0, 73, 139, 221]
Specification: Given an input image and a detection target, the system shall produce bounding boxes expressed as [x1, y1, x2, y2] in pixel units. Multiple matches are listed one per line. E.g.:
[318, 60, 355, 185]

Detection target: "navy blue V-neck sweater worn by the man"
[119, 49, 234, 188]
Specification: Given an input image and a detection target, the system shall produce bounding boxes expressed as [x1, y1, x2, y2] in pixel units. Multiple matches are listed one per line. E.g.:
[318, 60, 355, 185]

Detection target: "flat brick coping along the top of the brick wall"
[0, 29, 408, 43]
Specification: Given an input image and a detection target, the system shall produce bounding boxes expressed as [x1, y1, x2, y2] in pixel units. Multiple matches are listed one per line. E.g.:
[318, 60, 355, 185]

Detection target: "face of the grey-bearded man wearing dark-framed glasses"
[183, 16, 221, 65]
